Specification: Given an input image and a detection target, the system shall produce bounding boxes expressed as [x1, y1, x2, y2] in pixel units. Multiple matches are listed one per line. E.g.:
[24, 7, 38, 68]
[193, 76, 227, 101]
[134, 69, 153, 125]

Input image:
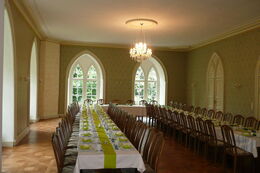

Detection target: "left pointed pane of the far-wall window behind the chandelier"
[134, 67, 145, 103]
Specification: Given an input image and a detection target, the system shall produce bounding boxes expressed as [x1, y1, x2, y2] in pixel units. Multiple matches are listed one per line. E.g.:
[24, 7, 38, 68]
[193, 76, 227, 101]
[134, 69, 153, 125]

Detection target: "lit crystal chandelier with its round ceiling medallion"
[126, 18, 158, 62]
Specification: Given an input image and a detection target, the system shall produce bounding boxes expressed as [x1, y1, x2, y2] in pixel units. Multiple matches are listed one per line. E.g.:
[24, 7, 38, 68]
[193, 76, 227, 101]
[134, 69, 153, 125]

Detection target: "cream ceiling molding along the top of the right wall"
[190, 19, 260, 50]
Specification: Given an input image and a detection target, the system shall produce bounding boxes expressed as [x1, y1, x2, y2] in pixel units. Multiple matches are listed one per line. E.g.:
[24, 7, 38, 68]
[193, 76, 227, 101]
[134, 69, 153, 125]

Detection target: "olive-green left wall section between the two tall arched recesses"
[6, 1, 39, 140]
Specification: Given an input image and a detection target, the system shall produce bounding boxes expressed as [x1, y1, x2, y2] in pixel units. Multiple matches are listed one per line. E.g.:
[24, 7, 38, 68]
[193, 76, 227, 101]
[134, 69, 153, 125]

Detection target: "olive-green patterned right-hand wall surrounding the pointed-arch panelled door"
[186, 28, 260, 116]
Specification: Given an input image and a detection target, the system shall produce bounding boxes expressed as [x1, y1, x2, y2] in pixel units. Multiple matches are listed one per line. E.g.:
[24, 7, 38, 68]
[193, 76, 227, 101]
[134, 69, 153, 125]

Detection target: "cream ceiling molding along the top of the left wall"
[12, 0, 46, 40]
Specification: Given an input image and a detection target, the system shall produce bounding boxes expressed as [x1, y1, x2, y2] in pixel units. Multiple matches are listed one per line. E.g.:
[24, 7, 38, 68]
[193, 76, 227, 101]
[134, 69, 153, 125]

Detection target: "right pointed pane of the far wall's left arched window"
[87, 65, 97, 101]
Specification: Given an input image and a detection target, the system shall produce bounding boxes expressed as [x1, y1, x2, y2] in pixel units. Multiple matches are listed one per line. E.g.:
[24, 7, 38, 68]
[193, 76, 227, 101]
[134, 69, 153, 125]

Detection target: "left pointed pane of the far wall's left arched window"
[72, 64, 84, 102]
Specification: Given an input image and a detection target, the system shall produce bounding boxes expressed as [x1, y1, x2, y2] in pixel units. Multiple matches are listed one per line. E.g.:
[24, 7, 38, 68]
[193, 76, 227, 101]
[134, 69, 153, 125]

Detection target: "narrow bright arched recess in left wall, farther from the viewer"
[30, 39, 38, 122]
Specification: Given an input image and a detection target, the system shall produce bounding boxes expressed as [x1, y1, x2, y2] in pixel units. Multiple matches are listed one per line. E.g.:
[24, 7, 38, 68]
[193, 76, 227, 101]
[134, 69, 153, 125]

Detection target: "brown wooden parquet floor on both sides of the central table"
[3, 119, 229, 173]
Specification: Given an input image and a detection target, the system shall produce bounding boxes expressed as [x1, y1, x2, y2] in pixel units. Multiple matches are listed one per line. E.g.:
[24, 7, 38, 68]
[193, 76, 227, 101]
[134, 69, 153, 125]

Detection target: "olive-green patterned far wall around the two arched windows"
[59, 45, 186, 114]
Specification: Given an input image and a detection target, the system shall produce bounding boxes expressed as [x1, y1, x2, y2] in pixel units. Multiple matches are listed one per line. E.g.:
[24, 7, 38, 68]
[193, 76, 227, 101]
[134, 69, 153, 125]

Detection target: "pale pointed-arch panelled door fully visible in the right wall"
[207, 53, 224, 111]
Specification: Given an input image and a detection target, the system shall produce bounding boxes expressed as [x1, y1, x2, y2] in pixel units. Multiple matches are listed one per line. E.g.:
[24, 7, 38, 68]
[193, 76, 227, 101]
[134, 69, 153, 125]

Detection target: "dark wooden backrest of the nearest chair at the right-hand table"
[221, 125, 237, 155]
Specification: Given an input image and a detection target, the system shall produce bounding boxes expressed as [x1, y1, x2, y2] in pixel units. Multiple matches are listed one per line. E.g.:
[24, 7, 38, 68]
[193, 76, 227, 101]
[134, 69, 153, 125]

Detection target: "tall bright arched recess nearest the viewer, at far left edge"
[2, 9, 15, 146]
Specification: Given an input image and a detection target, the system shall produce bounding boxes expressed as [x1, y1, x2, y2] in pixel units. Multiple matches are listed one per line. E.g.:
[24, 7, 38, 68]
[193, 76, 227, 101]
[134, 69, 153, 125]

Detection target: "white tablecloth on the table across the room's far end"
[101, 105, 146, 116]
